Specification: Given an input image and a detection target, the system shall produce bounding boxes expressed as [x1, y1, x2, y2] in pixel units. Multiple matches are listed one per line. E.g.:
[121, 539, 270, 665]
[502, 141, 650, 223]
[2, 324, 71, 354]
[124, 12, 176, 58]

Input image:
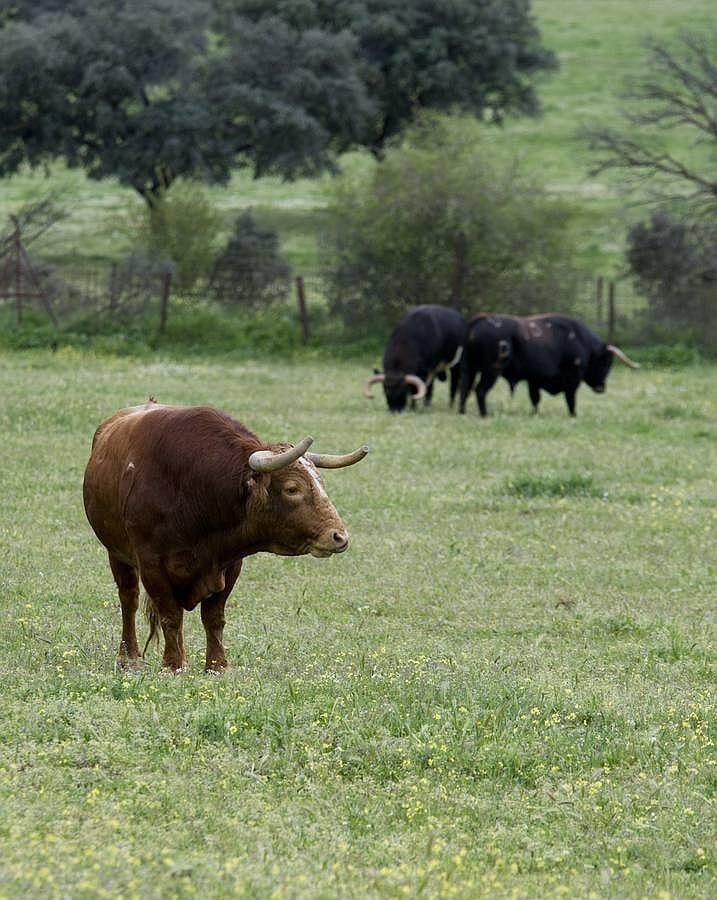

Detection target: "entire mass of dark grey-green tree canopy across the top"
[0, 0, 554, 205]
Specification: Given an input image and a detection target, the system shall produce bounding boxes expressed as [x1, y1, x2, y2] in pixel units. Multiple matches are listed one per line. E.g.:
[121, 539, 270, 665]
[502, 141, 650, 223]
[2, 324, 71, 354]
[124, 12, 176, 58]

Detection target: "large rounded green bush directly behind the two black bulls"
[323, 118, 576, 329]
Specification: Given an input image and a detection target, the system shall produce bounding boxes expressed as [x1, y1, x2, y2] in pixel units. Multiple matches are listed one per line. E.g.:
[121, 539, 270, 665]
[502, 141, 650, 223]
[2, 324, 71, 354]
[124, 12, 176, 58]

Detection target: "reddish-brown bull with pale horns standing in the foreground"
[83, 401, 368, 671]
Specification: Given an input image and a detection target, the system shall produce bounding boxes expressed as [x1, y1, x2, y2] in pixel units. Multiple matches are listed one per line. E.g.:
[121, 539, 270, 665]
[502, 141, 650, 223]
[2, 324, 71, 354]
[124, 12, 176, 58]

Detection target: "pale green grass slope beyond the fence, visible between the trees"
[0, 0, 714, 278]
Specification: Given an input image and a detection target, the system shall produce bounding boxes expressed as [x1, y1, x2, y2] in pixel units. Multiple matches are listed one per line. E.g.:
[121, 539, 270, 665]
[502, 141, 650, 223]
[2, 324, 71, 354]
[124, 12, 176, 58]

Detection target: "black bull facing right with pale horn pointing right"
[459, 313, 639, 416]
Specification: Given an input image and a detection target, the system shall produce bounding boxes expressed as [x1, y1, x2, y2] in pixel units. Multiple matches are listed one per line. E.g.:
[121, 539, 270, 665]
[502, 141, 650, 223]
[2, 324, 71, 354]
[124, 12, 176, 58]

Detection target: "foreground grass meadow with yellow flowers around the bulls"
[0, 350, 717, 900]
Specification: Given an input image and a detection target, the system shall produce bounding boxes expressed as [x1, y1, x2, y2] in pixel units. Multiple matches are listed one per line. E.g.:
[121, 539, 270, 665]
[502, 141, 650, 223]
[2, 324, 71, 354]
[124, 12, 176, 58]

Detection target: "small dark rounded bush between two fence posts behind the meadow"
[209, 212, 291, 309]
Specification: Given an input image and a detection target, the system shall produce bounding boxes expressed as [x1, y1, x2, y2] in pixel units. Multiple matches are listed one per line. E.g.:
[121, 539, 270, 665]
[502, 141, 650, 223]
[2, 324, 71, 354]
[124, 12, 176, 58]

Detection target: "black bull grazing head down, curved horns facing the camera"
[364, 304, 467, 412]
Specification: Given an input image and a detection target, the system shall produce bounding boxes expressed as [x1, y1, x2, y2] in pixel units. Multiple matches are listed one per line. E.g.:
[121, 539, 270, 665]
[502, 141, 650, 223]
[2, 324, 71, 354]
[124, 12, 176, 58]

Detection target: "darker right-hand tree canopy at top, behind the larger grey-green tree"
[228, 0, 556, 152]
